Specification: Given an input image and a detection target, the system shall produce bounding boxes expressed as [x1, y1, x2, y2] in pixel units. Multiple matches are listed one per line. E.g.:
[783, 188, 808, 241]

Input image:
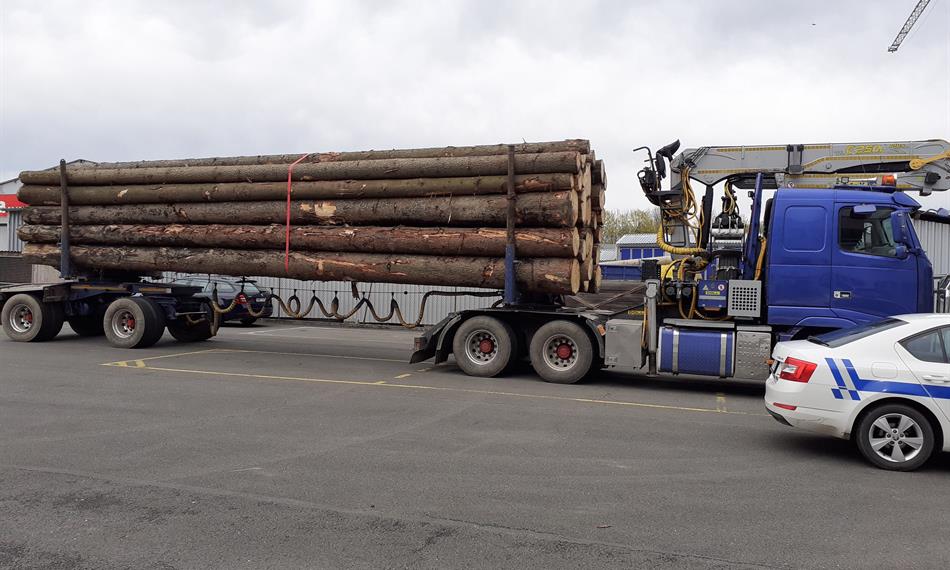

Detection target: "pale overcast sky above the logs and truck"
[0, 0, 950, 208]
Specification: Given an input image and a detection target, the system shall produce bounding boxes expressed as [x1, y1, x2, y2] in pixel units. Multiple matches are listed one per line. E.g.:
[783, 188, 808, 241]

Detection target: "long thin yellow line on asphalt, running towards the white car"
[109, 366, 765, 416]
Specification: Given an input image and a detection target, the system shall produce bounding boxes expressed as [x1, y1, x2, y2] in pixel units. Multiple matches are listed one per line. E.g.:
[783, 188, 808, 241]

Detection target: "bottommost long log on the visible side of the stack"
[23, 244, 581, 295]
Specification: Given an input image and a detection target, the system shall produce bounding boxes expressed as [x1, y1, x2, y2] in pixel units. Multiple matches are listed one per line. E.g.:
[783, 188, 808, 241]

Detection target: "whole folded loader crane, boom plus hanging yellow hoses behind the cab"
[638, 139, 950, 255]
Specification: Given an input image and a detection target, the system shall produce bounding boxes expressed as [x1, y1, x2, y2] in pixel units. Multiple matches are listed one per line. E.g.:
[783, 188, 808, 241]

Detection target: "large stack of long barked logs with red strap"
[18, 140, 606, 295]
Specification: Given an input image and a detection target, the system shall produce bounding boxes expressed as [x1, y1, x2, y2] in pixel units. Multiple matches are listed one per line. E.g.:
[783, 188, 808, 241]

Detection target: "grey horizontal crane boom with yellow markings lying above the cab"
[660, 139, 950, 195]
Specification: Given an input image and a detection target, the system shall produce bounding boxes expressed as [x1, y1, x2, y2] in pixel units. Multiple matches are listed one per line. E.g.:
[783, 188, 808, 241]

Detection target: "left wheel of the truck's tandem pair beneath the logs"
[452, 316, 515, 378]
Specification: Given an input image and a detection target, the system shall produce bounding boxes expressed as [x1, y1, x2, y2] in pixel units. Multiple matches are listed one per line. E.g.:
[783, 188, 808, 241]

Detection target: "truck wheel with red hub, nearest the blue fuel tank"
[530, 320, 594, 384]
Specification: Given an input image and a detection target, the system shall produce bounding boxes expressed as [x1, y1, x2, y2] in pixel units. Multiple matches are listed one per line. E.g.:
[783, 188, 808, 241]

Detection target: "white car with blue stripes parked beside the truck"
[765, 314, 950, 471]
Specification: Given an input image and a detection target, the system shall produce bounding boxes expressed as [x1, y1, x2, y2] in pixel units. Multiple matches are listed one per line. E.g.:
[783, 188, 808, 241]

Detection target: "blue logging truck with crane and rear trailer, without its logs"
[0, 140, 950, 383]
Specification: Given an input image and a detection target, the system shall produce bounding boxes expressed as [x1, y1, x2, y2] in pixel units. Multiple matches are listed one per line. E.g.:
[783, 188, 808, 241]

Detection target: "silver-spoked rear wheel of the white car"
[855, 404, 936, 471]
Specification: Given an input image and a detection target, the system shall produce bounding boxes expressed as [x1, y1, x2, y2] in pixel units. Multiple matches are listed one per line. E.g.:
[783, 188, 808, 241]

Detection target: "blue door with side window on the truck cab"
[831, 204, 917, 323]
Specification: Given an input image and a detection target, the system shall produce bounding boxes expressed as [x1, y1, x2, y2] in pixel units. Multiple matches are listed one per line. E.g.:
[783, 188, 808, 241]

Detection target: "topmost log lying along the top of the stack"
[91, 139, 593, 168]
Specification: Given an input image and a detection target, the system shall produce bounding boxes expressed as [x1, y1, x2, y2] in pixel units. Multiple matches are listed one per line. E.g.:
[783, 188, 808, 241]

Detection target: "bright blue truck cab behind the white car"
[763, 188, 933, 329]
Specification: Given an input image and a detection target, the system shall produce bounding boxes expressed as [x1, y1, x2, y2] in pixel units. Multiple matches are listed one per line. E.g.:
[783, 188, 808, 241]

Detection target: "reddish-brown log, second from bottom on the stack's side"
[17, 223, 588, 257]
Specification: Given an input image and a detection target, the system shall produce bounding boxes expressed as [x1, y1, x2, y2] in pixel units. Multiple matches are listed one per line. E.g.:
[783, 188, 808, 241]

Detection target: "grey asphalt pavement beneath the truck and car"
[0, 324, 950, 568]
